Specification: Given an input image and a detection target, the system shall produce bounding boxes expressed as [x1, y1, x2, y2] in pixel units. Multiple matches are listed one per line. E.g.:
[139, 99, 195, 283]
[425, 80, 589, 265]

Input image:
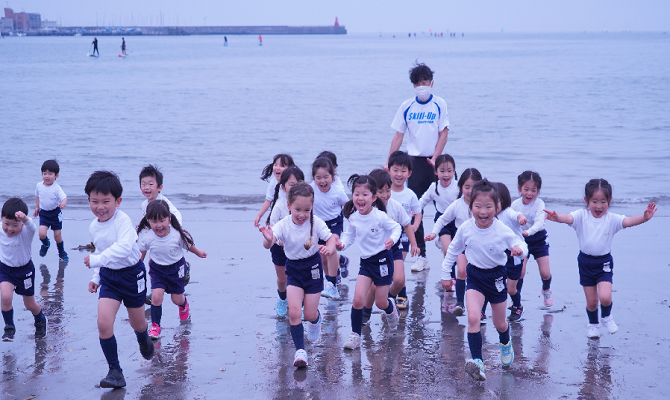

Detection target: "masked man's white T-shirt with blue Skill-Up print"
[391, 95, 449, 157]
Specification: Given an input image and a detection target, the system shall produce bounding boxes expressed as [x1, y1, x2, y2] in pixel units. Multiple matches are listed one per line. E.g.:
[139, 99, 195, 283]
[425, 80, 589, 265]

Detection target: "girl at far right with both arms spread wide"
[544, 179, 656, 338]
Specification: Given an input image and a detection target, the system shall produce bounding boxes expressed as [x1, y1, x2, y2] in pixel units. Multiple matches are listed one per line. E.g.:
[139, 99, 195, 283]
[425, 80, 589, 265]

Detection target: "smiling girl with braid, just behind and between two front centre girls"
[310, 157, 349, 299]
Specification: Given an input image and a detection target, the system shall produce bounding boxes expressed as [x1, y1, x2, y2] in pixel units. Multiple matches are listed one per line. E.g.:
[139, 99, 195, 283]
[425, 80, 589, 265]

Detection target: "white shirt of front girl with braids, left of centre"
[272, 215, 332, 260]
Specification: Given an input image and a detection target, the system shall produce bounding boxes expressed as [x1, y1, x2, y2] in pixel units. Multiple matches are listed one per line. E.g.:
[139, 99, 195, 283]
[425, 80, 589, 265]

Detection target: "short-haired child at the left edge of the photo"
[0, 197, 47, 342]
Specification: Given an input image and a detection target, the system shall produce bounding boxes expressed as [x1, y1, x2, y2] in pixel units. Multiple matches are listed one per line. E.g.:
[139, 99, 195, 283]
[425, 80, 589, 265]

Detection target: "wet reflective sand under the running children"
[0, 203, 670, 399]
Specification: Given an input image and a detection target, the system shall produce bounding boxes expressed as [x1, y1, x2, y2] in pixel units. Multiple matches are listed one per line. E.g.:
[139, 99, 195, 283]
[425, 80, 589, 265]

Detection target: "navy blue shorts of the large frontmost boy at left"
[98, 260, 147, 308]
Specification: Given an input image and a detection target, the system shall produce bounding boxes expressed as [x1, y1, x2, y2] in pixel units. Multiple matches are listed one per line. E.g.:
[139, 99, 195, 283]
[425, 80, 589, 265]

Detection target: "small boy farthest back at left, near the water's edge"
[33, 160, 69, 262]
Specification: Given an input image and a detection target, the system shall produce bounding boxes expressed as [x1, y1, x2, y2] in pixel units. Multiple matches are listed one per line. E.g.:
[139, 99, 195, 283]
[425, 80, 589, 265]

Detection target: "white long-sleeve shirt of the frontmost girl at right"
[442, 219, 528, 280]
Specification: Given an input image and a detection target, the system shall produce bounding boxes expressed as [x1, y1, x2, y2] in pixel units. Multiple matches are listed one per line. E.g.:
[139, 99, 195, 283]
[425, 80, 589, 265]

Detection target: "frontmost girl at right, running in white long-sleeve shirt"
[442, 179, 528, 380]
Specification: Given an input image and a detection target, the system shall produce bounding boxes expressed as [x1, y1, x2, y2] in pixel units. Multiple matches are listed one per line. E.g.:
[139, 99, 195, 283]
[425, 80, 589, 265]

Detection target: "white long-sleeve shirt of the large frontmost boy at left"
[88, 209, 141, 285]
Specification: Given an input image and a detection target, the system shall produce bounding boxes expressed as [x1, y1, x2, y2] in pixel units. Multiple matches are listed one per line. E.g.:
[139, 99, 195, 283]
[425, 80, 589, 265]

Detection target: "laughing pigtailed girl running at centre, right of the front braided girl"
[337, 175, 401, 350]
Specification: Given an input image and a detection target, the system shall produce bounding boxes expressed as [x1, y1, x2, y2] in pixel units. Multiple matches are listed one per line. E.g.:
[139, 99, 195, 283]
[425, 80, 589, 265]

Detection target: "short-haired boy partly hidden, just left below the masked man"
[388, 150, 428, 310]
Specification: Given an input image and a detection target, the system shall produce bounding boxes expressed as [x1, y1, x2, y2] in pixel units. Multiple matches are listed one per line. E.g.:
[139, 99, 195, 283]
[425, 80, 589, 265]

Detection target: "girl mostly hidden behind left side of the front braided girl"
[265, 166, 305, 318]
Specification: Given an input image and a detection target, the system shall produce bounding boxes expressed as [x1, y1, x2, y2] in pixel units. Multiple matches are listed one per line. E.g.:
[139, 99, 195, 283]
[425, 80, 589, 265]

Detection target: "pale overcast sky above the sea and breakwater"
[3, 0, 670, 33]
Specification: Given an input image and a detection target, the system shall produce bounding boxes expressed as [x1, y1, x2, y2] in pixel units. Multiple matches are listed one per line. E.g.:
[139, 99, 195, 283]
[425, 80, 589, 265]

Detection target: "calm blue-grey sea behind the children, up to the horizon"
[0, 33, 670, 211]
